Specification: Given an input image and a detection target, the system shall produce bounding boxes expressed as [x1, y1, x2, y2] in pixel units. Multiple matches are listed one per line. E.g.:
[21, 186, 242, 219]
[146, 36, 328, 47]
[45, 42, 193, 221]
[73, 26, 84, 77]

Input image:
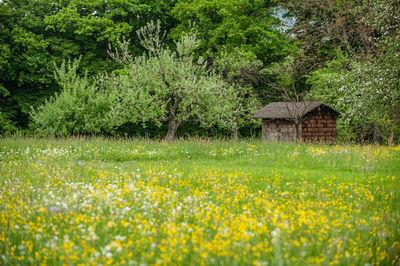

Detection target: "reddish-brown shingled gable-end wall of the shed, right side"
[301, 108, 337, 141]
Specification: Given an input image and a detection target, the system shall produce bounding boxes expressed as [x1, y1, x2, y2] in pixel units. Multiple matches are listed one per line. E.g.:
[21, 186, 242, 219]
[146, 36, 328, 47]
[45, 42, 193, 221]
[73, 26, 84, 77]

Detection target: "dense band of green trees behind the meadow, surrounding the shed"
[0, 0, 400, 144]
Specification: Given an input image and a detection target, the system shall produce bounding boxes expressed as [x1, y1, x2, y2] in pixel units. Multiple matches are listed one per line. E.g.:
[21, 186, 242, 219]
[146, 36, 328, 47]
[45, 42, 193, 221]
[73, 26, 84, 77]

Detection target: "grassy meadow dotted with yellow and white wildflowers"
[0, 138, 400, 265]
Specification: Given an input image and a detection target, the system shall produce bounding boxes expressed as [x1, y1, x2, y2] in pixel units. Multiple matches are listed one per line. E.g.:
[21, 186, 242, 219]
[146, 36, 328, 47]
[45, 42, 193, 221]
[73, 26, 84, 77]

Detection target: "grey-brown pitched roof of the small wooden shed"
[253, 102, 339, 119]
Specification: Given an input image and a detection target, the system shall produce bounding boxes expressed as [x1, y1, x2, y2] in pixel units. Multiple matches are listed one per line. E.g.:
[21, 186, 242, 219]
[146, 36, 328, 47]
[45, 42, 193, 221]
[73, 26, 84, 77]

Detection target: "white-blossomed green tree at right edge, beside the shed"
[308, 48, 400, 140]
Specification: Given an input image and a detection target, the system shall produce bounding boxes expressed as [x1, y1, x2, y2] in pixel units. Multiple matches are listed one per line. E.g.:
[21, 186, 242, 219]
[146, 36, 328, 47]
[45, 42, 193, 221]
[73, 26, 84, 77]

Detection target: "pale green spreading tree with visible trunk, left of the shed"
[105, 23, 239, 140]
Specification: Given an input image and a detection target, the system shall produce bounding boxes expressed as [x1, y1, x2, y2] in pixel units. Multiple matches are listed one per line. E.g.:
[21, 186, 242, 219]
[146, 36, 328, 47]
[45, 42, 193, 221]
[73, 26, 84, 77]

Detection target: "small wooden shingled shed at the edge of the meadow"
[253, 102, 339, 142]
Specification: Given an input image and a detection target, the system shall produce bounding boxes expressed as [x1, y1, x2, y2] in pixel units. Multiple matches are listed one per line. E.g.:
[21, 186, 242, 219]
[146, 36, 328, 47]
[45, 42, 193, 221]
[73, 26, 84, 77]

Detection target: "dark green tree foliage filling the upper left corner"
[0, 0, 172, 127]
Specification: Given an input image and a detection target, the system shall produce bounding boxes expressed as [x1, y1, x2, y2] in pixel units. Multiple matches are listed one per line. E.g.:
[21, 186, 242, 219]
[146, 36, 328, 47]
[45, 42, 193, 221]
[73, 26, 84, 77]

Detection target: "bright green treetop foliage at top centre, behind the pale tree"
[170, 0, 292, 64]
